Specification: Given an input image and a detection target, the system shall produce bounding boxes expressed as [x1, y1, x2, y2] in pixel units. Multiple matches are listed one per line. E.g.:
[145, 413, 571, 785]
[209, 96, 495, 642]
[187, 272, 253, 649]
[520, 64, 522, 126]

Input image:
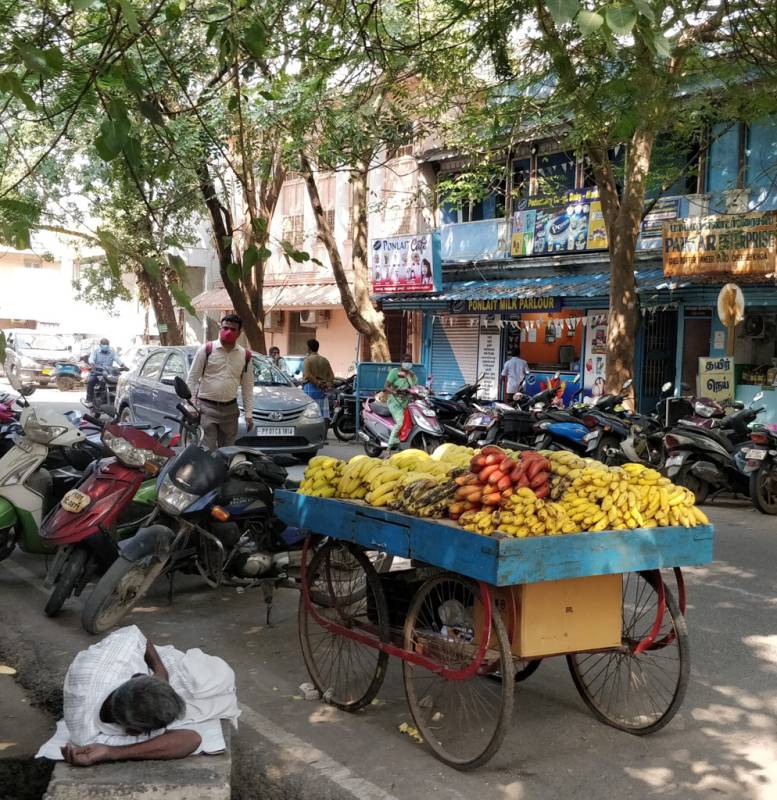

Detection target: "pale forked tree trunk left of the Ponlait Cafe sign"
[300, 153, 391, 361]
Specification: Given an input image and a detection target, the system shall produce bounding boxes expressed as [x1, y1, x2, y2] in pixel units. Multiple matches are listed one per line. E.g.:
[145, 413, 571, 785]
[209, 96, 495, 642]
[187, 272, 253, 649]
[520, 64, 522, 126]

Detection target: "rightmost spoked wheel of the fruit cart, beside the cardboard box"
[567, 572, 690, 736]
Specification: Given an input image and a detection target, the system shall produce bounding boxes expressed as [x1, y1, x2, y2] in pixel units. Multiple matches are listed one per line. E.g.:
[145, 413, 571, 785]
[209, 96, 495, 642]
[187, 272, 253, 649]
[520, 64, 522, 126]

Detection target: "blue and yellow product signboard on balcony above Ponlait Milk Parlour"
[510, 189, 607, 256]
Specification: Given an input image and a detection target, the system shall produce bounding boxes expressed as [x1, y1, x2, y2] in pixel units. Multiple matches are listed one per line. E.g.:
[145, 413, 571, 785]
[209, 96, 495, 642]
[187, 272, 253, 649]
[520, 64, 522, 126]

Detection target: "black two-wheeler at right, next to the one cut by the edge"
[664, 392, 765, 505]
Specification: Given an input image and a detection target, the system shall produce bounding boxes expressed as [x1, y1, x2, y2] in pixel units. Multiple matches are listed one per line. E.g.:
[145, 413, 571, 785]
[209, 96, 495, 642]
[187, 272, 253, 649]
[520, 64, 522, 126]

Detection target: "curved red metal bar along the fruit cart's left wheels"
[300, 536, 492, 681]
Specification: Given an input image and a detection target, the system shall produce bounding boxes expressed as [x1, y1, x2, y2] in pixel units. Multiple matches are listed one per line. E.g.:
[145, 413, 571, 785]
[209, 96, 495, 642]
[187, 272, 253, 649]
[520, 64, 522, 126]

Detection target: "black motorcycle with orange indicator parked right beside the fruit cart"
[81, 378, 296, 633]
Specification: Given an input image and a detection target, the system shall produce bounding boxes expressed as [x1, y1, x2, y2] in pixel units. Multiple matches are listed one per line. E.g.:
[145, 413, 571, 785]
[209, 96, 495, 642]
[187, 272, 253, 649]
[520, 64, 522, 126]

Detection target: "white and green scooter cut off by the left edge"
[0, 375, 86, 560]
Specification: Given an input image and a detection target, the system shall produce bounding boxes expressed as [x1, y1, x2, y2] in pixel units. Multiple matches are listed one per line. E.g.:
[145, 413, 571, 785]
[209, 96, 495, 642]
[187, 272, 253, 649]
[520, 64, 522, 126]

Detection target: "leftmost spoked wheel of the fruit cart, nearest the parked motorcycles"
[299, 541, 389, 711]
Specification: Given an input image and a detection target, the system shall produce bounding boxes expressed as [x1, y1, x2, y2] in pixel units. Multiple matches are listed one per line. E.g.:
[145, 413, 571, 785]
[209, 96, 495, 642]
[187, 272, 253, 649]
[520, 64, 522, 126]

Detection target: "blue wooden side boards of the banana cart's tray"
[275, 490, 714, 586]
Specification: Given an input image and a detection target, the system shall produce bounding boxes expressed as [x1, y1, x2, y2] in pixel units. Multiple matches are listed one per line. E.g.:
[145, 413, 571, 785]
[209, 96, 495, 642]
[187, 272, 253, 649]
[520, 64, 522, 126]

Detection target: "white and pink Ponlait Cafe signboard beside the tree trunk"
[370, 232, 442, 294]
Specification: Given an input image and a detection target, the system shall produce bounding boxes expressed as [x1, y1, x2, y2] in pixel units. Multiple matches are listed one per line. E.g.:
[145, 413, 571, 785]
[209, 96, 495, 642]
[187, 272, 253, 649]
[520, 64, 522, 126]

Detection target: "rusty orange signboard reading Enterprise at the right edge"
[663, 211, 777, 276]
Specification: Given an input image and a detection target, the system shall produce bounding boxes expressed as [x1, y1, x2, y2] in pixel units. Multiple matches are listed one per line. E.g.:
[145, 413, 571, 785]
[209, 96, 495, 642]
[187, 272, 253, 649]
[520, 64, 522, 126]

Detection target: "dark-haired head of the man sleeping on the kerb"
[111, 675, 186, 736]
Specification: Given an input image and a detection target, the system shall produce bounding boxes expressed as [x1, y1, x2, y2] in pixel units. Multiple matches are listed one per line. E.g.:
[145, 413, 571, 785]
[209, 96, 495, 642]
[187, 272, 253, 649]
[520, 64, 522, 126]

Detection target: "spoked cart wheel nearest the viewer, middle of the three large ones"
[402, 575, 515, 769]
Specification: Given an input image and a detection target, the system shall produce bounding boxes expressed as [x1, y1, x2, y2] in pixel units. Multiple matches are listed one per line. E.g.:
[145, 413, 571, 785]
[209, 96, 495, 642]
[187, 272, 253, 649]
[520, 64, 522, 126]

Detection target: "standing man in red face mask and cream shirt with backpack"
[187, 314, 254, 450]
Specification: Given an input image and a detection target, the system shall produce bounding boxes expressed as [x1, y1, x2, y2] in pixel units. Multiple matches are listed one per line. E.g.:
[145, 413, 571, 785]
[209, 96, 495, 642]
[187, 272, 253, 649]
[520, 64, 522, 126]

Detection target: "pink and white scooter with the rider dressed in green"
[359, 386, 443, 457]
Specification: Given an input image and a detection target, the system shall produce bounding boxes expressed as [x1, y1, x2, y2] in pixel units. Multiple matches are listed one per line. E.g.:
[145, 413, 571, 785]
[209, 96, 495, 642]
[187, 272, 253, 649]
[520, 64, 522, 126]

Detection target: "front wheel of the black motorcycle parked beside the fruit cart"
[81, 558, 167, 633]
